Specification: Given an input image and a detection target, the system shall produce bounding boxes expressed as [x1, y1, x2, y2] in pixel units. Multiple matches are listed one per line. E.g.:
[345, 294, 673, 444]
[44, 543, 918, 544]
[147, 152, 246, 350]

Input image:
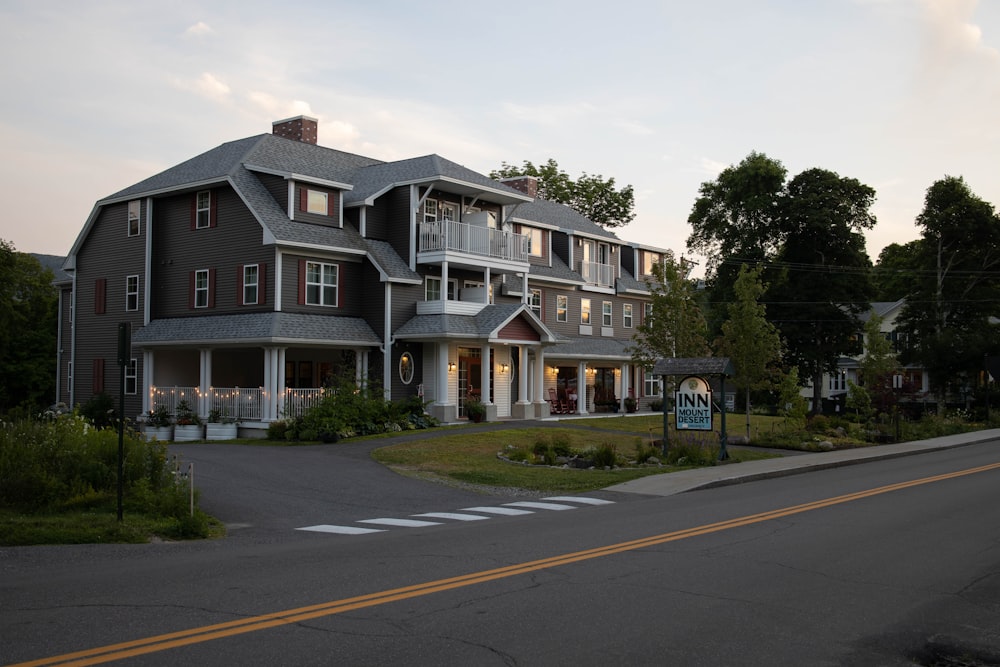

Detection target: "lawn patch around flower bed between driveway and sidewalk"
[372, 428, 772, 493]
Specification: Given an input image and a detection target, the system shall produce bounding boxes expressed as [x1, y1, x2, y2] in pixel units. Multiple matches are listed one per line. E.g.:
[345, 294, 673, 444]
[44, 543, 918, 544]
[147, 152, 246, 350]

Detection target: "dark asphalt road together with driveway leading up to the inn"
[0, 426, 1000, 666]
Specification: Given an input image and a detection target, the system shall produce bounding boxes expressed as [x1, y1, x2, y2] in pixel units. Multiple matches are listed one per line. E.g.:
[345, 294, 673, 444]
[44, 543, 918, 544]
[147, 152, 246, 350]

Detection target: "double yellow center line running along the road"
[11, 463, 1000, 667]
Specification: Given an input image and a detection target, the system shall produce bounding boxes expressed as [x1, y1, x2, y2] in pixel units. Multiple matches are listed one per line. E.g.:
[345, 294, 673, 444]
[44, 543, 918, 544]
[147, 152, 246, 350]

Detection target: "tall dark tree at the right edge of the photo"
[897, 176, 1000, 399]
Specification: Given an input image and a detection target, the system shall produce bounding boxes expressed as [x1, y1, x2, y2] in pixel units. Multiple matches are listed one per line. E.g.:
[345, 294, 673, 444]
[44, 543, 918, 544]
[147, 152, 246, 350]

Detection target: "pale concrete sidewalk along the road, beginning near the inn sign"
[605, 429, 1000, 496]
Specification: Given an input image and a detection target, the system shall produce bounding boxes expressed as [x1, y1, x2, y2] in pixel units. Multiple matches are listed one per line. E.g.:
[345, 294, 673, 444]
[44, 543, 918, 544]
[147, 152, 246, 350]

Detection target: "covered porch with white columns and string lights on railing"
[133, 313, 379, 428]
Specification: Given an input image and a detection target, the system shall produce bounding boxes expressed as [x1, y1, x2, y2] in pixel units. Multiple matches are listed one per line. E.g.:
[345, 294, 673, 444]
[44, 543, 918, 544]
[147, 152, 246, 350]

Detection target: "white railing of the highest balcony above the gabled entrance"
[417, 220, 528, 264]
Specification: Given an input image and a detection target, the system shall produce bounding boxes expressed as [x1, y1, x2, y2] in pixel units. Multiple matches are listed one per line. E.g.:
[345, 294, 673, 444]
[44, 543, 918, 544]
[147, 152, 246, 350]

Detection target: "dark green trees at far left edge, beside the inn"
[0, 239, 59, 413]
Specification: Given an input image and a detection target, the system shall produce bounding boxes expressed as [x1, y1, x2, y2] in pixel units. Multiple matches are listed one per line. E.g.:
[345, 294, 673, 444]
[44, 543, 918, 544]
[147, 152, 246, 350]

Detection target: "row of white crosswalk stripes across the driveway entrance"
[296, 496, 614, 535]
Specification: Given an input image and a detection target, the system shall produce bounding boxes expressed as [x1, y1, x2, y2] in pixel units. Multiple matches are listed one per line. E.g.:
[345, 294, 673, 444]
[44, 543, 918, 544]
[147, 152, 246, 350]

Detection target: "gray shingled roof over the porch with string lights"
[132, 312, 382, 347]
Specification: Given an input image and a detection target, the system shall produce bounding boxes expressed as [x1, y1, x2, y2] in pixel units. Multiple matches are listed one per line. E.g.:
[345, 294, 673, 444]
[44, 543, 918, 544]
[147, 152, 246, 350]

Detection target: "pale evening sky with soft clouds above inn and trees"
[0, 0, 1000, 276]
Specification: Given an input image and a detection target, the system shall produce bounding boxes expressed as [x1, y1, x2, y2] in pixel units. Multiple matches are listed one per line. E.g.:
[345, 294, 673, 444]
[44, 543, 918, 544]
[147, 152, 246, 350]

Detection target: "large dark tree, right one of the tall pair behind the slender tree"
[766, 169, 875, 414]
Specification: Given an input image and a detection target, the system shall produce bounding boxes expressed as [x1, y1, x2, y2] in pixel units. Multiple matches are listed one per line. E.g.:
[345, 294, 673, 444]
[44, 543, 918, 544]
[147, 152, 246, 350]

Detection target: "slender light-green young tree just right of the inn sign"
[717, 265, 781, 440]
